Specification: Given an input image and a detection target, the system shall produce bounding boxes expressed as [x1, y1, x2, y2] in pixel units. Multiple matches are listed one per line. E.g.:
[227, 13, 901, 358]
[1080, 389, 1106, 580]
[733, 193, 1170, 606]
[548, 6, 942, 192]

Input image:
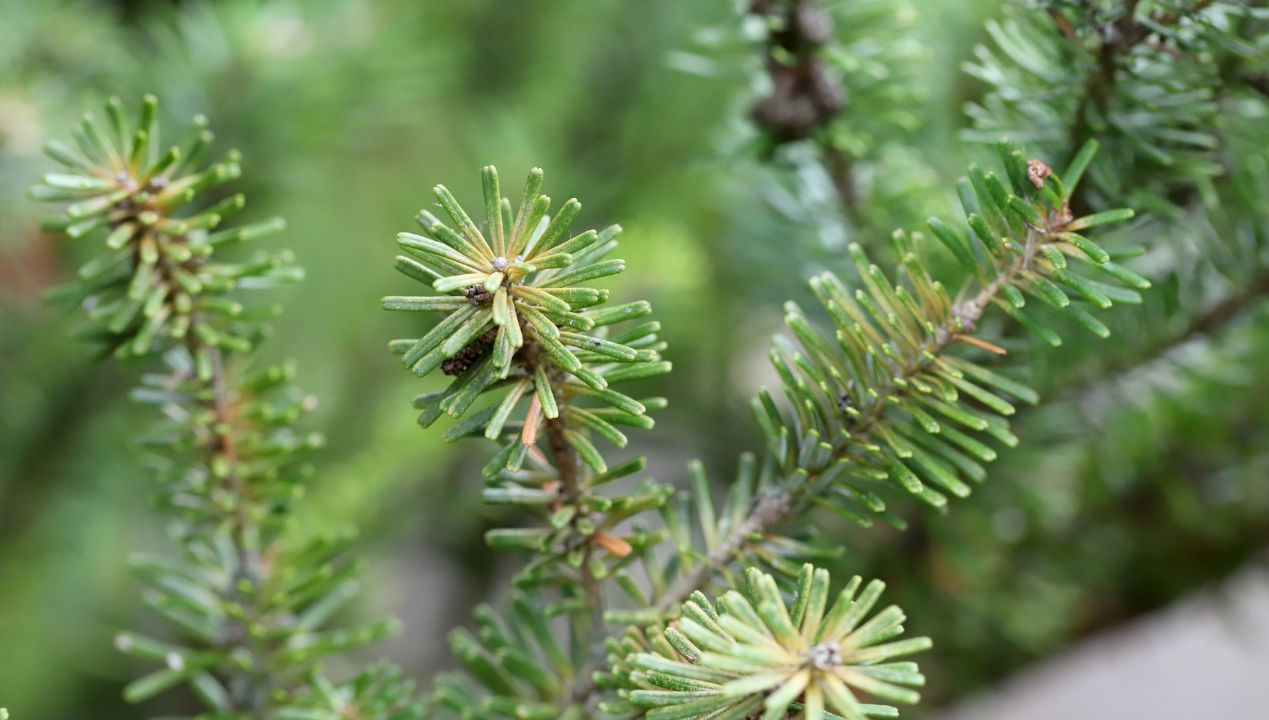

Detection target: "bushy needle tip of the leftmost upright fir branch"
[30, 95, 294, 365]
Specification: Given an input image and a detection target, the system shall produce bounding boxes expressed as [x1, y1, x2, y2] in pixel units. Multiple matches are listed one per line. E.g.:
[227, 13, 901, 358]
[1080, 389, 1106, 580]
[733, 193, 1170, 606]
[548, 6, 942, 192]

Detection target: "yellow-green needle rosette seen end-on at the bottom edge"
[623, 564, 930, 720]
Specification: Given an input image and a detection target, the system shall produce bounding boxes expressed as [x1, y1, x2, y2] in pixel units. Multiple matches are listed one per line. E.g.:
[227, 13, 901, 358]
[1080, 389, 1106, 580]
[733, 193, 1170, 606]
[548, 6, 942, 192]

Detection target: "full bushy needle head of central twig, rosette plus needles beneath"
[383, 166, 670, 476]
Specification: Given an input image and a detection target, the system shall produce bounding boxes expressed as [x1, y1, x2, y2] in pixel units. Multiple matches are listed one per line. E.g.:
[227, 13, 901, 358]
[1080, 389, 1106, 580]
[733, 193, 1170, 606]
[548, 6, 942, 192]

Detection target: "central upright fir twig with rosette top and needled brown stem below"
[383, 166, 670, 589]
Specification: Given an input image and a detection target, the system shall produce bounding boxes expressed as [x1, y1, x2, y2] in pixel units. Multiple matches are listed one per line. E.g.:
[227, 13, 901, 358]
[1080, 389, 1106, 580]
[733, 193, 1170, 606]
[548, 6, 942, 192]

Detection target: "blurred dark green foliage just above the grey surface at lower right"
[893, 303, 1269, 672]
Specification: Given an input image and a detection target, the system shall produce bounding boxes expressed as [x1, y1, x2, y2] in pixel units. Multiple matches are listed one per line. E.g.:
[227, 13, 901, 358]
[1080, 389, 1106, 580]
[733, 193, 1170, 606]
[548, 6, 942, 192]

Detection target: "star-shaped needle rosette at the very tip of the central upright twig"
[383, 166, 638, 389]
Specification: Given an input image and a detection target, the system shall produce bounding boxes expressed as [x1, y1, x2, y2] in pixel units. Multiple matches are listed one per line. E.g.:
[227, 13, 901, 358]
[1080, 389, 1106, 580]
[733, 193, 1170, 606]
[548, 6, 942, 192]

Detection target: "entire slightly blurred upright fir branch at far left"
[32, 97, 416, 719]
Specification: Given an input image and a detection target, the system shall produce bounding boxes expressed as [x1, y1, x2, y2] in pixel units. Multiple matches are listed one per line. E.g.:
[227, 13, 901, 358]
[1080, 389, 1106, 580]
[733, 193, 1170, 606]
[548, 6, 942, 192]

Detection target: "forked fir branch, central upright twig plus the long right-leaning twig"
[393, 145, 1148, 717]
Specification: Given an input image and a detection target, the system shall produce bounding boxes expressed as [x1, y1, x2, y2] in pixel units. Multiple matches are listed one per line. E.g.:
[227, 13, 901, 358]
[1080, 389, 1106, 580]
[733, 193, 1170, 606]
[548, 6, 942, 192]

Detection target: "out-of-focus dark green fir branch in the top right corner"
[963, 0, 1251, 213]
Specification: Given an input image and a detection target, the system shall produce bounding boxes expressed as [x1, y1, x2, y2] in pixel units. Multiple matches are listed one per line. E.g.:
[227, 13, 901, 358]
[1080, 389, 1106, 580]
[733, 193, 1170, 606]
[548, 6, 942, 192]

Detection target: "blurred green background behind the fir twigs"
[0, 0, 1269, 720]
